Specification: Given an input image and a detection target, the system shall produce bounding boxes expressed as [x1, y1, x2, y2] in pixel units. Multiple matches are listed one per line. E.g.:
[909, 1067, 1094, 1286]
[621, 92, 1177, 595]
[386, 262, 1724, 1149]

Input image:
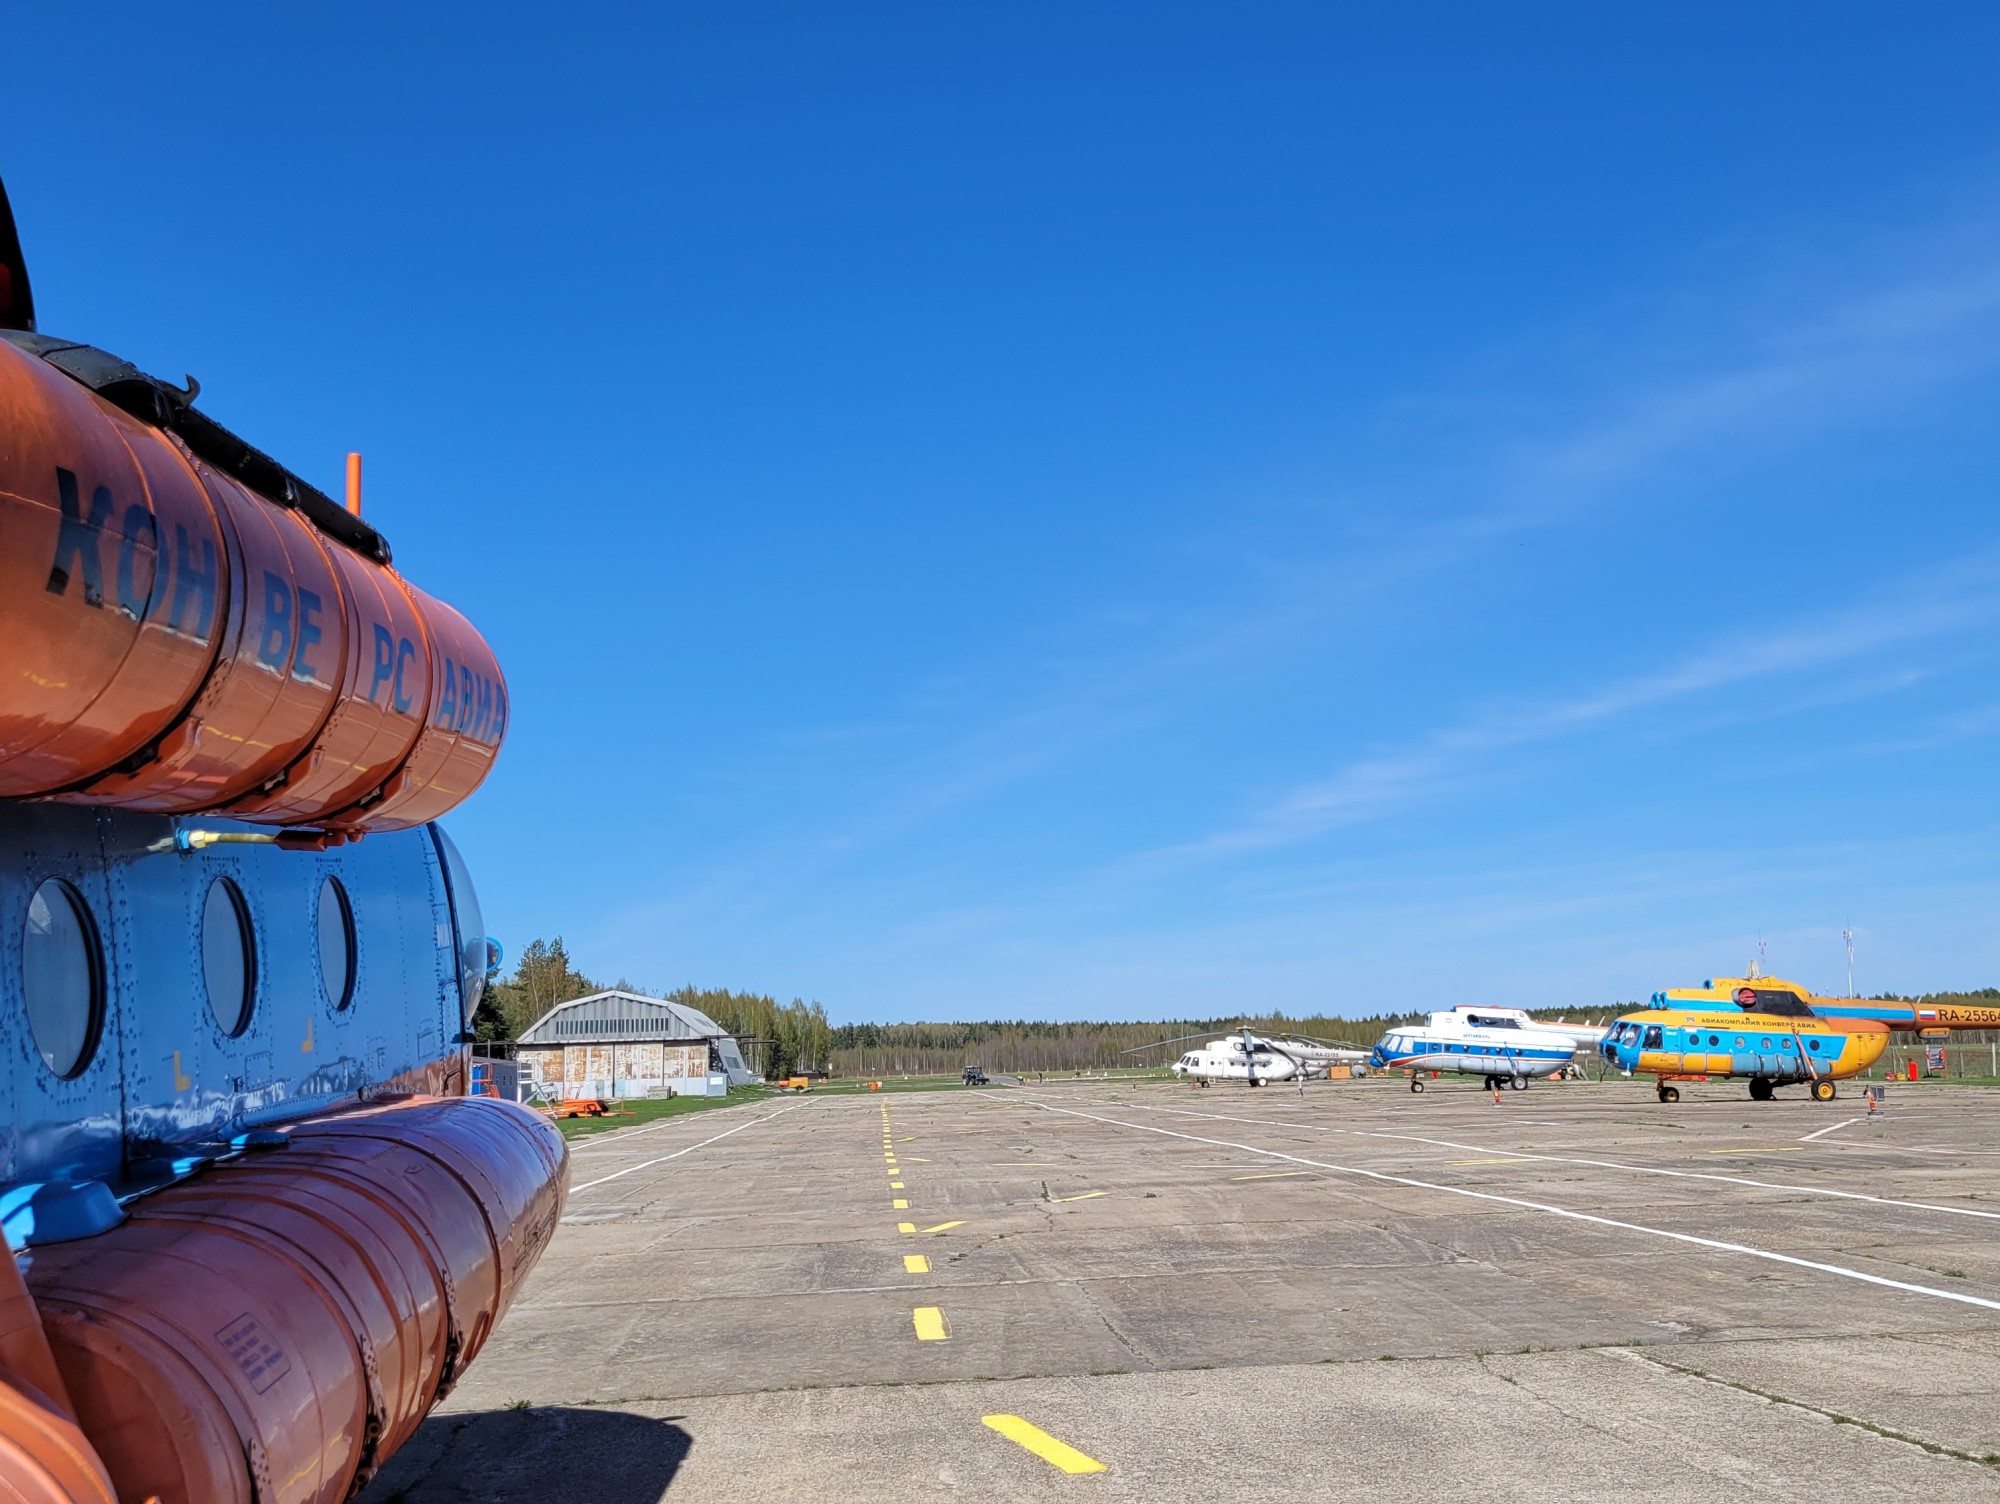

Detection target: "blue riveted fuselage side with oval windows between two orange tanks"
[0, 802, 486, 1196]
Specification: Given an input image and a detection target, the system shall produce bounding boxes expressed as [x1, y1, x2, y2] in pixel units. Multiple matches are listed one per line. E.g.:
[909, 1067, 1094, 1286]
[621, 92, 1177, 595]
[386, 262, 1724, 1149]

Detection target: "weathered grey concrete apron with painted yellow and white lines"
[362, 1082, 2000, 1504]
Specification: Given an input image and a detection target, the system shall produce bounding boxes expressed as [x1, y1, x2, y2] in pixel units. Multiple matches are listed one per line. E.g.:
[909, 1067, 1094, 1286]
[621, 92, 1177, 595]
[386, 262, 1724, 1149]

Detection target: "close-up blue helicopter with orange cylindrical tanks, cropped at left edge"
[0, 170, 568, 1504]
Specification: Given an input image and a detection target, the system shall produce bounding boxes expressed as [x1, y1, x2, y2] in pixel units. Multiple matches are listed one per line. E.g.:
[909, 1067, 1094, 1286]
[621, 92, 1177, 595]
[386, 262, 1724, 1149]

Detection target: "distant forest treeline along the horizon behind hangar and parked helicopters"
[474, 936, 2000, 1078]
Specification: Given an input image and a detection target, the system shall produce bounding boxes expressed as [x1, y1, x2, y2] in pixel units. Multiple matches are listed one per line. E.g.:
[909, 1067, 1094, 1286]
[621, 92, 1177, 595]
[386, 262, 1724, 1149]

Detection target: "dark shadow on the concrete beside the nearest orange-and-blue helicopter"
[354, 1406, 694, 1504]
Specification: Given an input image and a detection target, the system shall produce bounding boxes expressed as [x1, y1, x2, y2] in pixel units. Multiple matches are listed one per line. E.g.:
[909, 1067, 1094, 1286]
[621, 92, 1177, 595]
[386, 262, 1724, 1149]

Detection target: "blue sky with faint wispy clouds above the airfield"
[11, 2, 2000, 1020]
